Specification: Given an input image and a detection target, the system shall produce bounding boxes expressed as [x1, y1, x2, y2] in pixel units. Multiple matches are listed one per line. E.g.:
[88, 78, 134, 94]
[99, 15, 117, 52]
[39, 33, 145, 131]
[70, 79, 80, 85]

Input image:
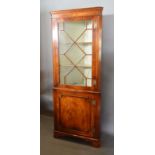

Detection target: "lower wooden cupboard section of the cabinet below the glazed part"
[53, 90, 100, 143]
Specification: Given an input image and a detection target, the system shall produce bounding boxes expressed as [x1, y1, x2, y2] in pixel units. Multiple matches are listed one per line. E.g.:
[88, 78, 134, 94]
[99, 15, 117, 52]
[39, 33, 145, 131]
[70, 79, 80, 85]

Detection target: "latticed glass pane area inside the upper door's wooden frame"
[59, 20, 93, 87]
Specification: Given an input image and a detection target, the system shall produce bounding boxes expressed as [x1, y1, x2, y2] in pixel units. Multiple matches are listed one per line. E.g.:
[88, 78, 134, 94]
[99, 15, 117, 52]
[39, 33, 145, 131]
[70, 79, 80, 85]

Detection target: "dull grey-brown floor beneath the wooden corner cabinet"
[40, 115, 114, 155]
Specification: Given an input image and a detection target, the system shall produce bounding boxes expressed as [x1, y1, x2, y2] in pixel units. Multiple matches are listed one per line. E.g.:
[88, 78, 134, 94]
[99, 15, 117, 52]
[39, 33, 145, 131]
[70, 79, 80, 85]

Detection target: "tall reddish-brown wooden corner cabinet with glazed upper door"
[50, 7, 103, 147]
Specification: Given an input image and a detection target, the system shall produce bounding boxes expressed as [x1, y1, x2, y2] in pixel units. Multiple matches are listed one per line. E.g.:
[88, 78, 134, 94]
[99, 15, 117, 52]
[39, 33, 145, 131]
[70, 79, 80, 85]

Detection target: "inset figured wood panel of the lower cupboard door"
[59, 95, 91, 132]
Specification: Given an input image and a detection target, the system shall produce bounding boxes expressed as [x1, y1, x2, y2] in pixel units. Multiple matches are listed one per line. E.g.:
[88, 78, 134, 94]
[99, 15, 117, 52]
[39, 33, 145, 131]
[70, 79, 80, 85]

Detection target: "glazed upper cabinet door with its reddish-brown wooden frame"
[53, 17, 98, 90]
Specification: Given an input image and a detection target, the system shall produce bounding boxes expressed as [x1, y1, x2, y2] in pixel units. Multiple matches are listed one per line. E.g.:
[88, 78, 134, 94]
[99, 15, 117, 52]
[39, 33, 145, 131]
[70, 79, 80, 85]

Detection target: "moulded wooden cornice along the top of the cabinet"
[49, 7, 103, 18]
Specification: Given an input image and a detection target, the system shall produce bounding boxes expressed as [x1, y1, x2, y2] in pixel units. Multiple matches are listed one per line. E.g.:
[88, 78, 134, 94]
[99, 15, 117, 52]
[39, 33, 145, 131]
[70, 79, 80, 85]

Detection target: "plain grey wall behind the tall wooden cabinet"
[40, 0, 114, 135]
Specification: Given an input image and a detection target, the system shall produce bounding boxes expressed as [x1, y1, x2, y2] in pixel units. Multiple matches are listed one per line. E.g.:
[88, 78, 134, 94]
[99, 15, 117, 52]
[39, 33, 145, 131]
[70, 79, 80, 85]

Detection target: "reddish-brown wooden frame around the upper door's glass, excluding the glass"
[52, 16, 102, 91]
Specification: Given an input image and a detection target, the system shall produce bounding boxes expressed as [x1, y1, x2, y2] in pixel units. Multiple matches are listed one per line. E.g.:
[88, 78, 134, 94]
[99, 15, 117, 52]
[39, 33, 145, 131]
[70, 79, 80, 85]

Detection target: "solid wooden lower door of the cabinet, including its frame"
[54, 92, 98, 137]
